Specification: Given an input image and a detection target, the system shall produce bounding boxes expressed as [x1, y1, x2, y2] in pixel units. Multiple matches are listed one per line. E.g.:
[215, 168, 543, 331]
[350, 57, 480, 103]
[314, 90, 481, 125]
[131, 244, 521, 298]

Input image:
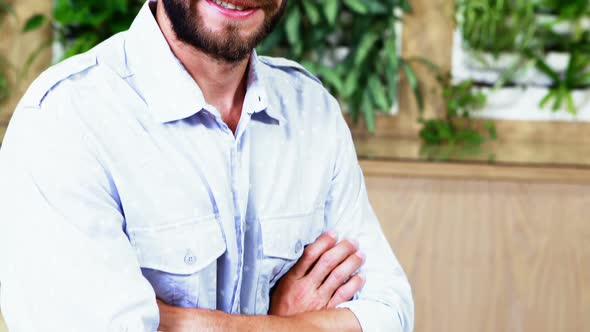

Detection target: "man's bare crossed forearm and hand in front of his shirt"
[158, 232, 365, 332]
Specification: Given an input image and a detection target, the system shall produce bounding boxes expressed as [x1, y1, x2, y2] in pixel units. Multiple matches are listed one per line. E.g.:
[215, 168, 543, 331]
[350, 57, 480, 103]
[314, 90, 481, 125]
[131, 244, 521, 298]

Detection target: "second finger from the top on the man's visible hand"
[307, 240, 358, 287]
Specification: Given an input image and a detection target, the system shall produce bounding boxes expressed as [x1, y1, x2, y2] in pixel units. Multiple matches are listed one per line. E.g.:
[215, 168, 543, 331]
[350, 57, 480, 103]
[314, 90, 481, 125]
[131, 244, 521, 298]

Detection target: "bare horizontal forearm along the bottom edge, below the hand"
[160, 305, 361, 332]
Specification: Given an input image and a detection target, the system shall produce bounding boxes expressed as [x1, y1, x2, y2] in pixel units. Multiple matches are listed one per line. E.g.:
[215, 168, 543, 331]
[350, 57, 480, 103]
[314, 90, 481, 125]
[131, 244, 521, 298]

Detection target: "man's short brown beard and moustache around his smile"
[162, 0, 287, 64]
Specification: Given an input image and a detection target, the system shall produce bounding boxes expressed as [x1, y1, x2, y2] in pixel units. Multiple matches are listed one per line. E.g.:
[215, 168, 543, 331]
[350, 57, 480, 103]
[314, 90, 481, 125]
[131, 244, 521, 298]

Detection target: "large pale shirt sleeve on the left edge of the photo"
[0, 92, 159, 332]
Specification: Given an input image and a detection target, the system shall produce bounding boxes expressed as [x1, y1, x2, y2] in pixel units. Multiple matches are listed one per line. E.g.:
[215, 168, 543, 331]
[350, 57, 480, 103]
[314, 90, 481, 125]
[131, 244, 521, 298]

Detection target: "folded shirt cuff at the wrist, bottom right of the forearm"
[336, 300, 403, 332]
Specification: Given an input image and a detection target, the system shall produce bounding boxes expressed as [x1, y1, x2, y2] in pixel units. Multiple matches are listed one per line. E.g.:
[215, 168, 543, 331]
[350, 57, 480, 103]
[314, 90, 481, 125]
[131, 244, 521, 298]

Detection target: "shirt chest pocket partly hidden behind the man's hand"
[256, 206, 324, 314]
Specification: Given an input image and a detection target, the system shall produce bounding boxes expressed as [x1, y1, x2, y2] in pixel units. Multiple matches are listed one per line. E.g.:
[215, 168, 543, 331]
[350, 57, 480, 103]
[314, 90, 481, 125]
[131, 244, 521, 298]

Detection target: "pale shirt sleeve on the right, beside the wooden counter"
[326, 105, 414, 331]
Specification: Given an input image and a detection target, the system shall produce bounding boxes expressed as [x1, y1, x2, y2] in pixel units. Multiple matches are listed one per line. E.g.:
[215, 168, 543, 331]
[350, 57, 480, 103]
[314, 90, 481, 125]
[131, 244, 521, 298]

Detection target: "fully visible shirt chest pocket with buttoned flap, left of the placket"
[128, 215, 226, 309]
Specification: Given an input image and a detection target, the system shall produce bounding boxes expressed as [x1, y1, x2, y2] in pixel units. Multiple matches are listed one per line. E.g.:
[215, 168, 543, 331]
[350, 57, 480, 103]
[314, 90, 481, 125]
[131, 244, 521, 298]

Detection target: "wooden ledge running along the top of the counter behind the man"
[355, 137, 590, 184]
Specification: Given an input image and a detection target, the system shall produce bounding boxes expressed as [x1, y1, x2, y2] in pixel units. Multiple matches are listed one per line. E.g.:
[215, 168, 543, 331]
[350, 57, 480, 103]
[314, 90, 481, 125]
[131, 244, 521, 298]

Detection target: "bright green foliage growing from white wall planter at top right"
[456, 0, 590, 114]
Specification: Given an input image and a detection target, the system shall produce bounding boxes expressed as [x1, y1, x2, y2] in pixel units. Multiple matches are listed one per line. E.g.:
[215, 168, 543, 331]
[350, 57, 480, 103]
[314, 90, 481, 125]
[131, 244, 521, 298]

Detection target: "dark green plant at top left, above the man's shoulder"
[53, 0, 145, 58]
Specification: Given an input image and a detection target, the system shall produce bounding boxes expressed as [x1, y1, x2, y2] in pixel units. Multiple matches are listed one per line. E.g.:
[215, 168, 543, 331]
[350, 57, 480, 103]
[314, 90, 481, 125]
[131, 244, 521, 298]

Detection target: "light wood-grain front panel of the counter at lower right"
[367, 177, 590, 332]
